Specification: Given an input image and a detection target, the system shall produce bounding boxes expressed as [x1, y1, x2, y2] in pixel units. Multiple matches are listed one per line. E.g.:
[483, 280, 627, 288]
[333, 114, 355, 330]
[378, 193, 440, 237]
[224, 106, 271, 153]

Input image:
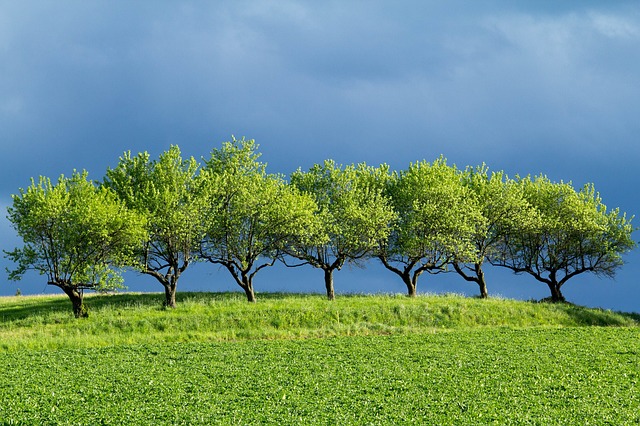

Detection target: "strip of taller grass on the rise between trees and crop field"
[0, 293, 640, 351]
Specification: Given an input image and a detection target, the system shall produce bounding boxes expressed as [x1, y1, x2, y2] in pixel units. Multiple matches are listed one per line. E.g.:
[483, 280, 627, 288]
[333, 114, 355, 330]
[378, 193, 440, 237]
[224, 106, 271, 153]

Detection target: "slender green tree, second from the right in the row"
[452, 164, 537, 298]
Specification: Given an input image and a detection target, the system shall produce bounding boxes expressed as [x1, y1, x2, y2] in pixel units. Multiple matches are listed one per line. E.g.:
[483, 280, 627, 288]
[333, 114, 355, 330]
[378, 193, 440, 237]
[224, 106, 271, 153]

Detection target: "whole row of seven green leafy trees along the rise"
[6, 138, 636, 317]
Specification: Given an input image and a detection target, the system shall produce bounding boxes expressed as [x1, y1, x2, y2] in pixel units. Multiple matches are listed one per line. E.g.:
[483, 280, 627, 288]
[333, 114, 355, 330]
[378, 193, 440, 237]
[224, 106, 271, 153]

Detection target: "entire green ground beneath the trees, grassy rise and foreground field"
[0, 294, 640, 425]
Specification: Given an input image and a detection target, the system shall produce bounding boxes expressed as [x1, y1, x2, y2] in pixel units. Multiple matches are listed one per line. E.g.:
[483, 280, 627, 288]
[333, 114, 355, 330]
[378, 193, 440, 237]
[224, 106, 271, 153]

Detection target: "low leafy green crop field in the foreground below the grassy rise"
[0, 320, 640, 425]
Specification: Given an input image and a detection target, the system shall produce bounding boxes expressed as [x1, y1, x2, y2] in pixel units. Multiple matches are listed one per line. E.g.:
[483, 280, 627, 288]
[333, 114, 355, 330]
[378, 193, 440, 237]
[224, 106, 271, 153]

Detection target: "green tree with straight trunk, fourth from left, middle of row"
[286, 160, 394, 300]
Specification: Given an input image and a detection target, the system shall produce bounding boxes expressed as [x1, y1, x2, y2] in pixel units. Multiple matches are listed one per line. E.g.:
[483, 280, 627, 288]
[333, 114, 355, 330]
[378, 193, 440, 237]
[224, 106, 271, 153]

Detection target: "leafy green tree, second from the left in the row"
[104, 145, 202, 308]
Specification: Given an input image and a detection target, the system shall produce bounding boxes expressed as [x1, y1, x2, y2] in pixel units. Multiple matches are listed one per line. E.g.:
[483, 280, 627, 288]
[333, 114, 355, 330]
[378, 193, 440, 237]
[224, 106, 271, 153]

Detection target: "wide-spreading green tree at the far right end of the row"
[492, 175, 636, 302]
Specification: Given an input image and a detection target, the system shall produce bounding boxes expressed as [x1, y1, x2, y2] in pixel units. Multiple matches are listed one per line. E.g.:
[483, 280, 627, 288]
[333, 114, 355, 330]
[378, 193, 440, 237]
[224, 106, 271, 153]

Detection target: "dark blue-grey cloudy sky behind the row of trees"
[0, 0, 640, 311]
